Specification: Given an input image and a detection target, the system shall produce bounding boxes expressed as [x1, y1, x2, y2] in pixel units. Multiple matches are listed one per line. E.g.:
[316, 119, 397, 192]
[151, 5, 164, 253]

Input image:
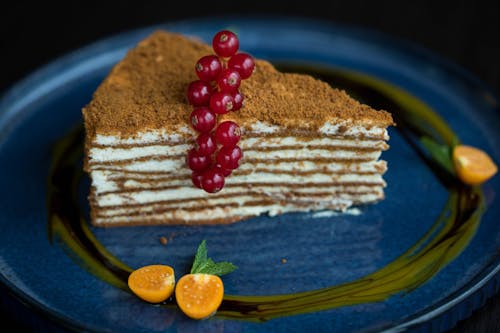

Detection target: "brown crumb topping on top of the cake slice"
[83, 31, 393, 142]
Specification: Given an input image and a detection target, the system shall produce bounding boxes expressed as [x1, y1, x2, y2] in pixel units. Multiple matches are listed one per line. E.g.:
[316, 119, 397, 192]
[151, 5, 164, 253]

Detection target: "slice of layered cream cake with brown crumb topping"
[83, 31, 393, 226]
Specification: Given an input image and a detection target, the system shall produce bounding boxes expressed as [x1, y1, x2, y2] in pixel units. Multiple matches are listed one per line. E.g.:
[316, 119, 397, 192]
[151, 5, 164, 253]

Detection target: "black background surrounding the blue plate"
[0, 0, 500, 333]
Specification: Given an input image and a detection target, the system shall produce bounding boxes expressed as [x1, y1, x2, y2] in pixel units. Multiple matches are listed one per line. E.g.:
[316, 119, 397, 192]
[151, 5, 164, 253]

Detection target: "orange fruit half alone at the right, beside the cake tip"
[453, 145, 498, 185]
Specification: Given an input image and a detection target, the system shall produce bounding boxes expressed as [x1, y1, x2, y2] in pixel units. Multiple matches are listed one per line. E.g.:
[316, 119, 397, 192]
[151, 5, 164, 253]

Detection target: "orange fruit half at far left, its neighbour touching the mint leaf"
[128, 265, 175, 303]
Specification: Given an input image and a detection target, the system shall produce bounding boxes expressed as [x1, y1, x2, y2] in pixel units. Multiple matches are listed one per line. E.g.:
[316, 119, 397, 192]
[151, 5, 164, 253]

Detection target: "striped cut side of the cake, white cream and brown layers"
[87, 132, 388, 225]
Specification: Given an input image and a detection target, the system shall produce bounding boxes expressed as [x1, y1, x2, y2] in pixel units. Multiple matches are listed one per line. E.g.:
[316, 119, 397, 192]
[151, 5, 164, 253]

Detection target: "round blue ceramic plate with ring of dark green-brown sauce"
[0, 18, 500, 332]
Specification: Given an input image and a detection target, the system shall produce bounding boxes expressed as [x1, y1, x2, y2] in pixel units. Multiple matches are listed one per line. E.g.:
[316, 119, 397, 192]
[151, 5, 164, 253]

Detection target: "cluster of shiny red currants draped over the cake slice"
[187, 30, 255, 193]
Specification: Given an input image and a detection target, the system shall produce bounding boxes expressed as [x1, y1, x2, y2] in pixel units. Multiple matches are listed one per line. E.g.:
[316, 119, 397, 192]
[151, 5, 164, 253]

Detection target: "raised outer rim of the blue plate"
[0, 14, 500, 332]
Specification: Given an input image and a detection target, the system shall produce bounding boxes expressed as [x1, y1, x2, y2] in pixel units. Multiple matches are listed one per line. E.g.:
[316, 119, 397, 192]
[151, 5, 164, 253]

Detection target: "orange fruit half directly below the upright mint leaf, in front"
[175, 273, 224, 319]
